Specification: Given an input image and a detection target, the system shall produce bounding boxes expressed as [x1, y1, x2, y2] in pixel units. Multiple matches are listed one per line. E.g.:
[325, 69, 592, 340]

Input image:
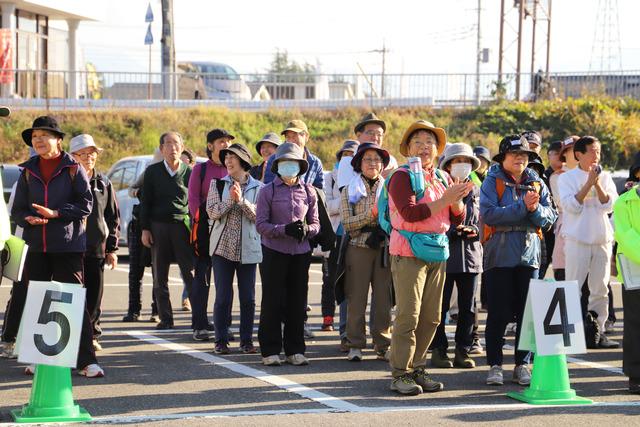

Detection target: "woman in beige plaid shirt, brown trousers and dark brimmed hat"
[340, 142, 393, 361]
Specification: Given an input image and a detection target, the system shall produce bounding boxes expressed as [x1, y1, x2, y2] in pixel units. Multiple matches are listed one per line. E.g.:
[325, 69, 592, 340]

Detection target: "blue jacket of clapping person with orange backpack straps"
[480, 165, 558, 271]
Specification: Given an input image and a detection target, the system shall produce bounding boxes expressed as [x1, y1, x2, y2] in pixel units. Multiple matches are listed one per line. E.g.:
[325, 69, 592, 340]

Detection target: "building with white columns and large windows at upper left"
[0, 0, 97, 98]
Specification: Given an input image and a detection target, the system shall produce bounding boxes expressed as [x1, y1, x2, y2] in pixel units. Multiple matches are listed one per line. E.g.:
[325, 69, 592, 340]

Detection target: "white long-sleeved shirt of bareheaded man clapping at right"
[558, 167, 618, 245]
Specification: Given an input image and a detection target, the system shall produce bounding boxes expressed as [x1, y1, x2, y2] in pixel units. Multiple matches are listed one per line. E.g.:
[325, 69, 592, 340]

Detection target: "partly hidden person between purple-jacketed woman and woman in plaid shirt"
[321, 139, 358, 334]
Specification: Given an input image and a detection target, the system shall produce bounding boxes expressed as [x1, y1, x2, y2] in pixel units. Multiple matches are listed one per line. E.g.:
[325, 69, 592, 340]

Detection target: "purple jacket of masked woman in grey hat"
[256, 178, 320, 255]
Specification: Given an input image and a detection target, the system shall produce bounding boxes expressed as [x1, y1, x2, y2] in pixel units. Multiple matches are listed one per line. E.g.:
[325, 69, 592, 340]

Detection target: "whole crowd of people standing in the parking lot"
[2, 109, 640, 395]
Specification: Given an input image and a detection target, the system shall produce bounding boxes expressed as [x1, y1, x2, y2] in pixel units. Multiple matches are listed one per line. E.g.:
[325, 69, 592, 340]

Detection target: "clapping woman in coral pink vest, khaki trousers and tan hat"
[388, 120, 473, 395]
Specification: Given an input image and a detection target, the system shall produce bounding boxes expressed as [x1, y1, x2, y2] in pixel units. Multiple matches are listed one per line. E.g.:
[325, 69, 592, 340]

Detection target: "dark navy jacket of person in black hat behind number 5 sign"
[11, 151, 93, 253]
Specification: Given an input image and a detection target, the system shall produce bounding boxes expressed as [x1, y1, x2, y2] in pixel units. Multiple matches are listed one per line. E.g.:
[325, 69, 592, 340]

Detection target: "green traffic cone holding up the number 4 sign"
[507, 354, 593, 405]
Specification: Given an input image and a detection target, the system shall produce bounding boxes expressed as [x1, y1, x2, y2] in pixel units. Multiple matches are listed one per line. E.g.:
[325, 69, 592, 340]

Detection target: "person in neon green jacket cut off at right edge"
[613, 177, 640, 394]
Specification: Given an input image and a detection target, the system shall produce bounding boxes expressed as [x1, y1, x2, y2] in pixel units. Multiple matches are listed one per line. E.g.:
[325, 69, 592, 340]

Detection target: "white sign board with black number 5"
[16, 281, 86, 368]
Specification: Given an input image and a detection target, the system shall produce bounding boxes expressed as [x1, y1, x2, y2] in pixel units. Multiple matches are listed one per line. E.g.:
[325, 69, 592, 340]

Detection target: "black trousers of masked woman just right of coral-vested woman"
[431, 273, 478, 351]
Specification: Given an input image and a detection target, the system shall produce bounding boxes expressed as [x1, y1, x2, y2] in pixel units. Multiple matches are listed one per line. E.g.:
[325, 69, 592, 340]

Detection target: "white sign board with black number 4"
[518, 280, 587, 356]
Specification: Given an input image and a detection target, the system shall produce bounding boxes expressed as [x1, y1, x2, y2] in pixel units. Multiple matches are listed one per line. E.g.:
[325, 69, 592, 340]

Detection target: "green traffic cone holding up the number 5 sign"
[11, 365, 91, 423]
